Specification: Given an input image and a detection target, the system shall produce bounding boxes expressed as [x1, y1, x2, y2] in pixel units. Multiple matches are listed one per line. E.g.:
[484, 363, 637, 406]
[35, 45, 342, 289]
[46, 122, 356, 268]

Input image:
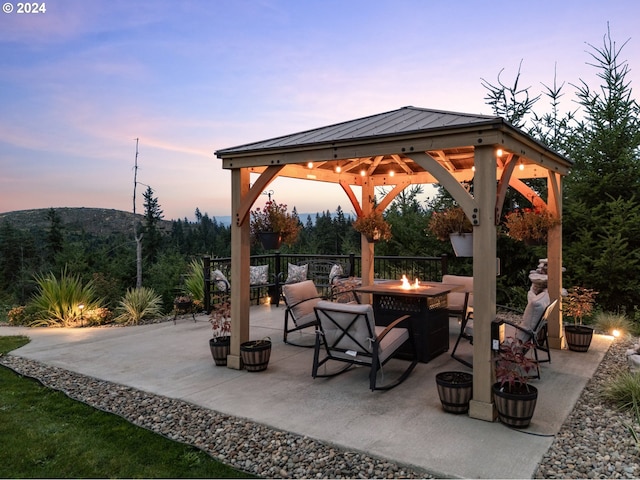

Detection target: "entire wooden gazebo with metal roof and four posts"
[215, 107, 572, 421]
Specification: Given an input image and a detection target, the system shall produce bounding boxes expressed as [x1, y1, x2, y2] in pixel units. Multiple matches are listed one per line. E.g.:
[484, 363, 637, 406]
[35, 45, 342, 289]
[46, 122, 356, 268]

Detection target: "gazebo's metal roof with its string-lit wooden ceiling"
[216, 107, 572, 185]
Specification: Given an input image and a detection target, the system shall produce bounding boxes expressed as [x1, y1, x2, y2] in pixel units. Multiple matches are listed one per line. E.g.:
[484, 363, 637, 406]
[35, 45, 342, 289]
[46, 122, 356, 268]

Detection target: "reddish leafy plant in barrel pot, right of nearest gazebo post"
[492, 338, 538, 428]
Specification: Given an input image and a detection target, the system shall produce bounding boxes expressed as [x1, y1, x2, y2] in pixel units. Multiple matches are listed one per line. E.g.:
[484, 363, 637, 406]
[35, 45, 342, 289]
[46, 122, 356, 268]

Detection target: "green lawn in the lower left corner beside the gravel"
[0, 337, 251, 478]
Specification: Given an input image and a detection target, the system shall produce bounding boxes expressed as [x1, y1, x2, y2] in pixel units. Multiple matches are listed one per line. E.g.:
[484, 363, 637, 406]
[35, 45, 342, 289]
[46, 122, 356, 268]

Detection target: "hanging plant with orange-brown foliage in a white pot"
[428, 207, 473, 257]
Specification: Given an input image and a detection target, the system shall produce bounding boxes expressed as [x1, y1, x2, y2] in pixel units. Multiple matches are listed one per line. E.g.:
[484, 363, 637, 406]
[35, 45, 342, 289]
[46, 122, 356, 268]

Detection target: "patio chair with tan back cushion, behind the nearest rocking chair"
[282, 280, 322, 347]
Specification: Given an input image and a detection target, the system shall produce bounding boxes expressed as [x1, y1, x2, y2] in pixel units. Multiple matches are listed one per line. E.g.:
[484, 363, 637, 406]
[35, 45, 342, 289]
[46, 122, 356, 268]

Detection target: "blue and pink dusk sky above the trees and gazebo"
[0, 0, 640, 219]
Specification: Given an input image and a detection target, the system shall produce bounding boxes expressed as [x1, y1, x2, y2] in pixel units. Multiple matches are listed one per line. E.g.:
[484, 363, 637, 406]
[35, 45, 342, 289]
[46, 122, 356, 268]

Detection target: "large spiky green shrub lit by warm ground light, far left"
[27, 269, 102, 327]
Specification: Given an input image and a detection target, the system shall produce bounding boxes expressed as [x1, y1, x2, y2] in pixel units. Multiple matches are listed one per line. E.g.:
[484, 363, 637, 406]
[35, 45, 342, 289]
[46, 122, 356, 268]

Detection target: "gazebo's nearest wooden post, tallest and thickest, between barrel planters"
[469, 146, 497, 422]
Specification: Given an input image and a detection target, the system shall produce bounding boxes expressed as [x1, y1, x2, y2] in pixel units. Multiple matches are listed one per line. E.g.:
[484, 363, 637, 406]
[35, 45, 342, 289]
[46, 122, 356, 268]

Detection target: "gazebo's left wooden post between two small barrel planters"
[227, 168, 251, 370]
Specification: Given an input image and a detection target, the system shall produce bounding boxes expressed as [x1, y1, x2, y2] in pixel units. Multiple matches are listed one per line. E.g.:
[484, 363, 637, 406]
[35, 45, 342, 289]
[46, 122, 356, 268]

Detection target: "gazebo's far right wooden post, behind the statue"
[547, 171, 564, 349]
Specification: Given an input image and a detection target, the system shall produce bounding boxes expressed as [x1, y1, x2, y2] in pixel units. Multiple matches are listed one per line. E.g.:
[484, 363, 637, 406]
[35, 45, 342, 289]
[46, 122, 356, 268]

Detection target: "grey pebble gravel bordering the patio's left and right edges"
[0, 340, 640, 478]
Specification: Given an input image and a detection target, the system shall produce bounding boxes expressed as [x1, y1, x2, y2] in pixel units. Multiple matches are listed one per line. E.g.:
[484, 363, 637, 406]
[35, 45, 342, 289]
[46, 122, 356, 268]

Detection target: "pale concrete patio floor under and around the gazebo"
[0, 305, 611, 478]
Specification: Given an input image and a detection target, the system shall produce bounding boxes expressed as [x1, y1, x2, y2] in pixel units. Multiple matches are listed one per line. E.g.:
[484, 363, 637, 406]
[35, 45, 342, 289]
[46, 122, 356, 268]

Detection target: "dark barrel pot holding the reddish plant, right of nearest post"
[492, 382, 538, 428]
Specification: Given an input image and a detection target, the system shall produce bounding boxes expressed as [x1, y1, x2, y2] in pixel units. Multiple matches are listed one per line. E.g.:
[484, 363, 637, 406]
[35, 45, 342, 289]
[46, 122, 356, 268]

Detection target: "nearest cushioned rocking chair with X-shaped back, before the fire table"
[312, 300, 418, 391]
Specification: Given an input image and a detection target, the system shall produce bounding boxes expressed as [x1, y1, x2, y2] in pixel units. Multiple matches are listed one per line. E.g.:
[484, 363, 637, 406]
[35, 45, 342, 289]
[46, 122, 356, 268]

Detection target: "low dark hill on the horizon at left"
[0, 207, 171, 235]
